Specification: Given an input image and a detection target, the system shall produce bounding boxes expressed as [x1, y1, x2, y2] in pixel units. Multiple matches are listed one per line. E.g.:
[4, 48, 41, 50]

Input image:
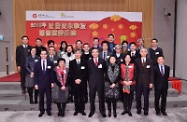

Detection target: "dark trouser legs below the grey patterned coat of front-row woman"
[106, 98, 117, 112]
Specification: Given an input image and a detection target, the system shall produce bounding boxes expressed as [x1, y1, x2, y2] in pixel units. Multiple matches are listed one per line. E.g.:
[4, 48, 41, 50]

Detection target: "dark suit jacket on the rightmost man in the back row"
[148, 47, 163, 65]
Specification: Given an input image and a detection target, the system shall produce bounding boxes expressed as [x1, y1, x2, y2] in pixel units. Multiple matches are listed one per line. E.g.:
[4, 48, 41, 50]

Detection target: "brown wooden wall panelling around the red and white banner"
[13, 0, 153, 49]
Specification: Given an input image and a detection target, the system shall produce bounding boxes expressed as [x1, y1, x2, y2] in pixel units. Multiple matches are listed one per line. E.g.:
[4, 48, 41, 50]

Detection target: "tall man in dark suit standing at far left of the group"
[16, 36, 31, 94]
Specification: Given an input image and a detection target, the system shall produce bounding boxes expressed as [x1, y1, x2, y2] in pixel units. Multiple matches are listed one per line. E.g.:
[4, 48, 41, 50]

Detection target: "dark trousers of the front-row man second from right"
[136, 83, 150, 112]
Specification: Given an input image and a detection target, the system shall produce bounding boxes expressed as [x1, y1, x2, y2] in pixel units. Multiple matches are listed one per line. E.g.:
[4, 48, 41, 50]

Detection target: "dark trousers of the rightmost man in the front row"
[155, 89, 167, 112]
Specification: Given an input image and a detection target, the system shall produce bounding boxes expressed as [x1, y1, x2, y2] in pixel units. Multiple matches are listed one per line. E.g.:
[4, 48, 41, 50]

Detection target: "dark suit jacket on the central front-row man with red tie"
[88, 58, 106, 88]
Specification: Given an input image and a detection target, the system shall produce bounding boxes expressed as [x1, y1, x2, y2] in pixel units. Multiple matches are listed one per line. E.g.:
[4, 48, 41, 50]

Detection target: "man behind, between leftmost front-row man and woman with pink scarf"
[47, 47, 59, 67]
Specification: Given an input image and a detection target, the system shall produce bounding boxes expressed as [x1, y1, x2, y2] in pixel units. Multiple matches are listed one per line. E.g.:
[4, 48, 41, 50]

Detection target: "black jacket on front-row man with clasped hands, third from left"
[69, 59, 87, 87]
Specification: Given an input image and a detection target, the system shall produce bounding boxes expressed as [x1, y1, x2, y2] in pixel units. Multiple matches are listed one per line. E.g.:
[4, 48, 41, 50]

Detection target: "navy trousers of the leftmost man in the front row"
[39, 86, 52, 112]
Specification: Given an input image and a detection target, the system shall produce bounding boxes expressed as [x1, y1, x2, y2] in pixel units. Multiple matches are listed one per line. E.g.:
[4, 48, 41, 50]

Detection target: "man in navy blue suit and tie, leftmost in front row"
[34, 50, 54, 117]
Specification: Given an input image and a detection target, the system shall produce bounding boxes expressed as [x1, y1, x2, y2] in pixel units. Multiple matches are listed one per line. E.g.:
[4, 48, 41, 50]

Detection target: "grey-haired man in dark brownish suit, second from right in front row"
[135, 48, 154, 116]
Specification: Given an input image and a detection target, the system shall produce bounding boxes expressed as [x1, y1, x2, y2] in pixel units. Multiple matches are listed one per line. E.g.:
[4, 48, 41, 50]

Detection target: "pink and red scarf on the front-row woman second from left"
[56, 66, 66, 86]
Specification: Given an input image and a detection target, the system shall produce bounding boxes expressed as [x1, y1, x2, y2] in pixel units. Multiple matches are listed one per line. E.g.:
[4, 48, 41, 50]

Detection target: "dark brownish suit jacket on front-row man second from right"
[135, 58, 154, 88]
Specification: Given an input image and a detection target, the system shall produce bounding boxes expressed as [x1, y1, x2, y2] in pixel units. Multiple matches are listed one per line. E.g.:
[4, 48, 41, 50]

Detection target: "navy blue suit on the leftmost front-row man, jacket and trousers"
[34, 60, 54, 112]
